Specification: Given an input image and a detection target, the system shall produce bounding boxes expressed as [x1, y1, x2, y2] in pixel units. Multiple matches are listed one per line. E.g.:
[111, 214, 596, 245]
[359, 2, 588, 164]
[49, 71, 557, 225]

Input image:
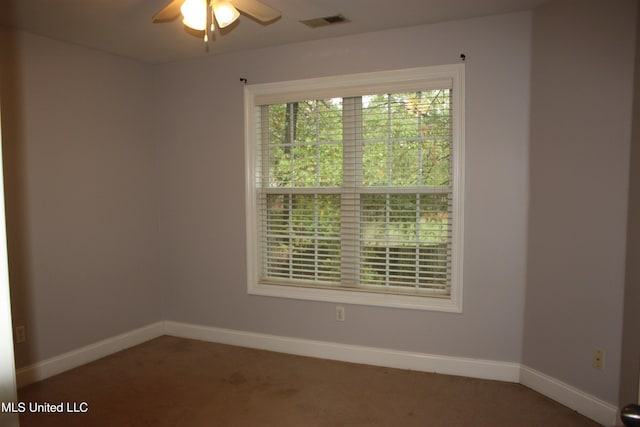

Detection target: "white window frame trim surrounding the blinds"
[244, 64, 465, 313]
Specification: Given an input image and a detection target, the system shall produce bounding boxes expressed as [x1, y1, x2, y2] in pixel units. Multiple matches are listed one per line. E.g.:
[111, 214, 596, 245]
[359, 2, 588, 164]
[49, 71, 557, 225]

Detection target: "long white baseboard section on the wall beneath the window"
[165, 322, 520, 382]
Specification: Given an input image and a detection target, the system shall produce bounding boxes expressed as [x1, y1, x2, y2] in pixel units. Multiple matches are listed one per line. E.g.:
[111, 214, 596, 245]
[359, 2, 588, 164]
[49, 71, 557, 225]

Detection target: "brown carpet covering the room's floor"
[18, 336, 598, 427]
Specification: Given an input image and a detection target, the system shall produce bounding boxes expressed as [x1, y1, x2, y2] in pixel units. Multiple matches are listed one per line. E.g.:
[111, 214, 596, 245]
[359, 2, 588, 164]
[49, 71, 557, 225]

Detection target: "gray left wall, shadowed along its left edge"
[0, 31, 160, 366]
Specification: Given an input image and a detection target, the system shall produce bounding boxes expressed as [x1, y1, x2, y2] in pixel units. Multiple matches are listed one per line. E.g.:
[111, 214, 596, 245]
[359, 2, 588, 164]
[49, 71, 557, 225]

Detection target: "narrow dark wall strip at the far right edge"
[620, 1, 640, 406]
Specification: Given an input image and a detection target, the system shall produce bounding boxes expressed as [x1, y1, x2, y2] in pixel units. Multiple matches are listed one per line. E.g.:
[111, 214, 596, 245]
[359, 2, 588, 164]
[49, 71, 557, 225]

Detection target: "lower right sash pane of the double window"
[360, 194, 451, 294]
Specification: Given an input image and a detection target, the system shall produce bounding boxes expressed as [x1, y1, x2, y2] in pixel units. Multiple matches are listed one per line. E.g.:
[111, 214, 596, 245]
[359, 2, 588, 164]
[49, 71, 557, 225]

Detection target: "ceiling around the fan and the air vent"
[0, 0, 547, 63]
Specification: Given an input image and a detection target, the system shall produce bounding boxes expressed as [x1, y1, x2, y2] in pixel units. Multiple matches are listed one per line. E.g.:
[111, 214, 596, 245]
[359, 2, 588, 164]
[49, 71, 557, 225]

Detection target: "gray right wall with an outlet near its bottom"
[523, 0, 635, 403]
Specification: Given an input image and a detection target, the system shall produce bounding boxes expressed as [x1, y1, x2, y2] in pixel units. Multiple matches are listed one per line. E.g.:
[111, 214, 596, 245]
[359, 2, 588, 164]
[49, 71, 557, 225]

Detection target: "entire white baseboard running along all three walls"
[11, 321, 618, 426]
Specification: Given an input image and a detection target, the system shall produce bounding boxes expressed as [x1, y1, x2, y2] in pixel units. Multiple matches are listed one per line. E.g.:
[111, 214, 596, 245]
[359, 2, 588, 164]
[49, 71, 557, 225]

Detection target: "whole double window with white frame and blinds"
[245, 64, 464, 312]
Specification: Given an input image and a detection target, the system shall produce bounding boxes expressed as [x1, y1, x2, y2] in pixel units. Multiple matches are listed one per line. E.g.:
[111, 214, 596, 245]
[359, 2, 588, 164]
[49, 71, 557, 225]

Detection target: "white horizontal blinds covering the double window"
[255, 86, 455, 297]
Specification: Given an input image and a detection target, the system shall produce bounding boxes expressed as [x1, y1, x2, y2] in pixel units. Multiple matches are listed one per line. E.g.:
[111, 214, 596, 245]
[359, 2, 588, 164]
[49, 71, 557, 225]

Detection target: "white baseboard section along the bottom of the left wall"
[16, 322, 164, 387]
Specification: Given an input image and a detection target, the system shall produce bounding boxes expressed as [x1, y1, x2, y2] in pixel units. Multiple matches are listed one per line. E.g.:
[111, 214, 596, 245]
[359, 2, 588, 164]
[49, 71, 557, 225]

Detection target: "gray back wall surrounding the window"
[158, 13, 531, 362]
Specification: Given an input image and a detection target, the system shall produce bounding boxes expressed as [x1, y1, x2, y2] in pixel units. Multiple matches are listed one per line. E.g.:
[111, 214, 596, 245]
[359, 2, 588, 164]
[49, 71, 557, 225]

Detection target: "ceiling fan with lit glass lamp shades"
[152, 0, 280, 41]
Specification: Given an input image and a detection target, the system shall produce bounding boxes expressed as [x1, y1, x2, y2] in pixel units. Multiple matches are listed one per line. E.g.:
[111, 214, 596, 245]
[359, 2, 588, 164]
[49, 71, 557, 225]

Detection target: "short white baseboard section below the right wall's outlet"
[520, 365, 618, 426]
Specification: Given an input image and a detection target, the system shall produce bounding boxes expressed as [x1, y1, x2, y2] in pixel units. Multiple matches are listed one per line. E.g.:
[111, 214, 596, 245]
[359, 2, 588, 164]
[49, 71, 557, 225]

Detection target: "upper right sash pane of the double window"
[362, 89, 451, 186]
